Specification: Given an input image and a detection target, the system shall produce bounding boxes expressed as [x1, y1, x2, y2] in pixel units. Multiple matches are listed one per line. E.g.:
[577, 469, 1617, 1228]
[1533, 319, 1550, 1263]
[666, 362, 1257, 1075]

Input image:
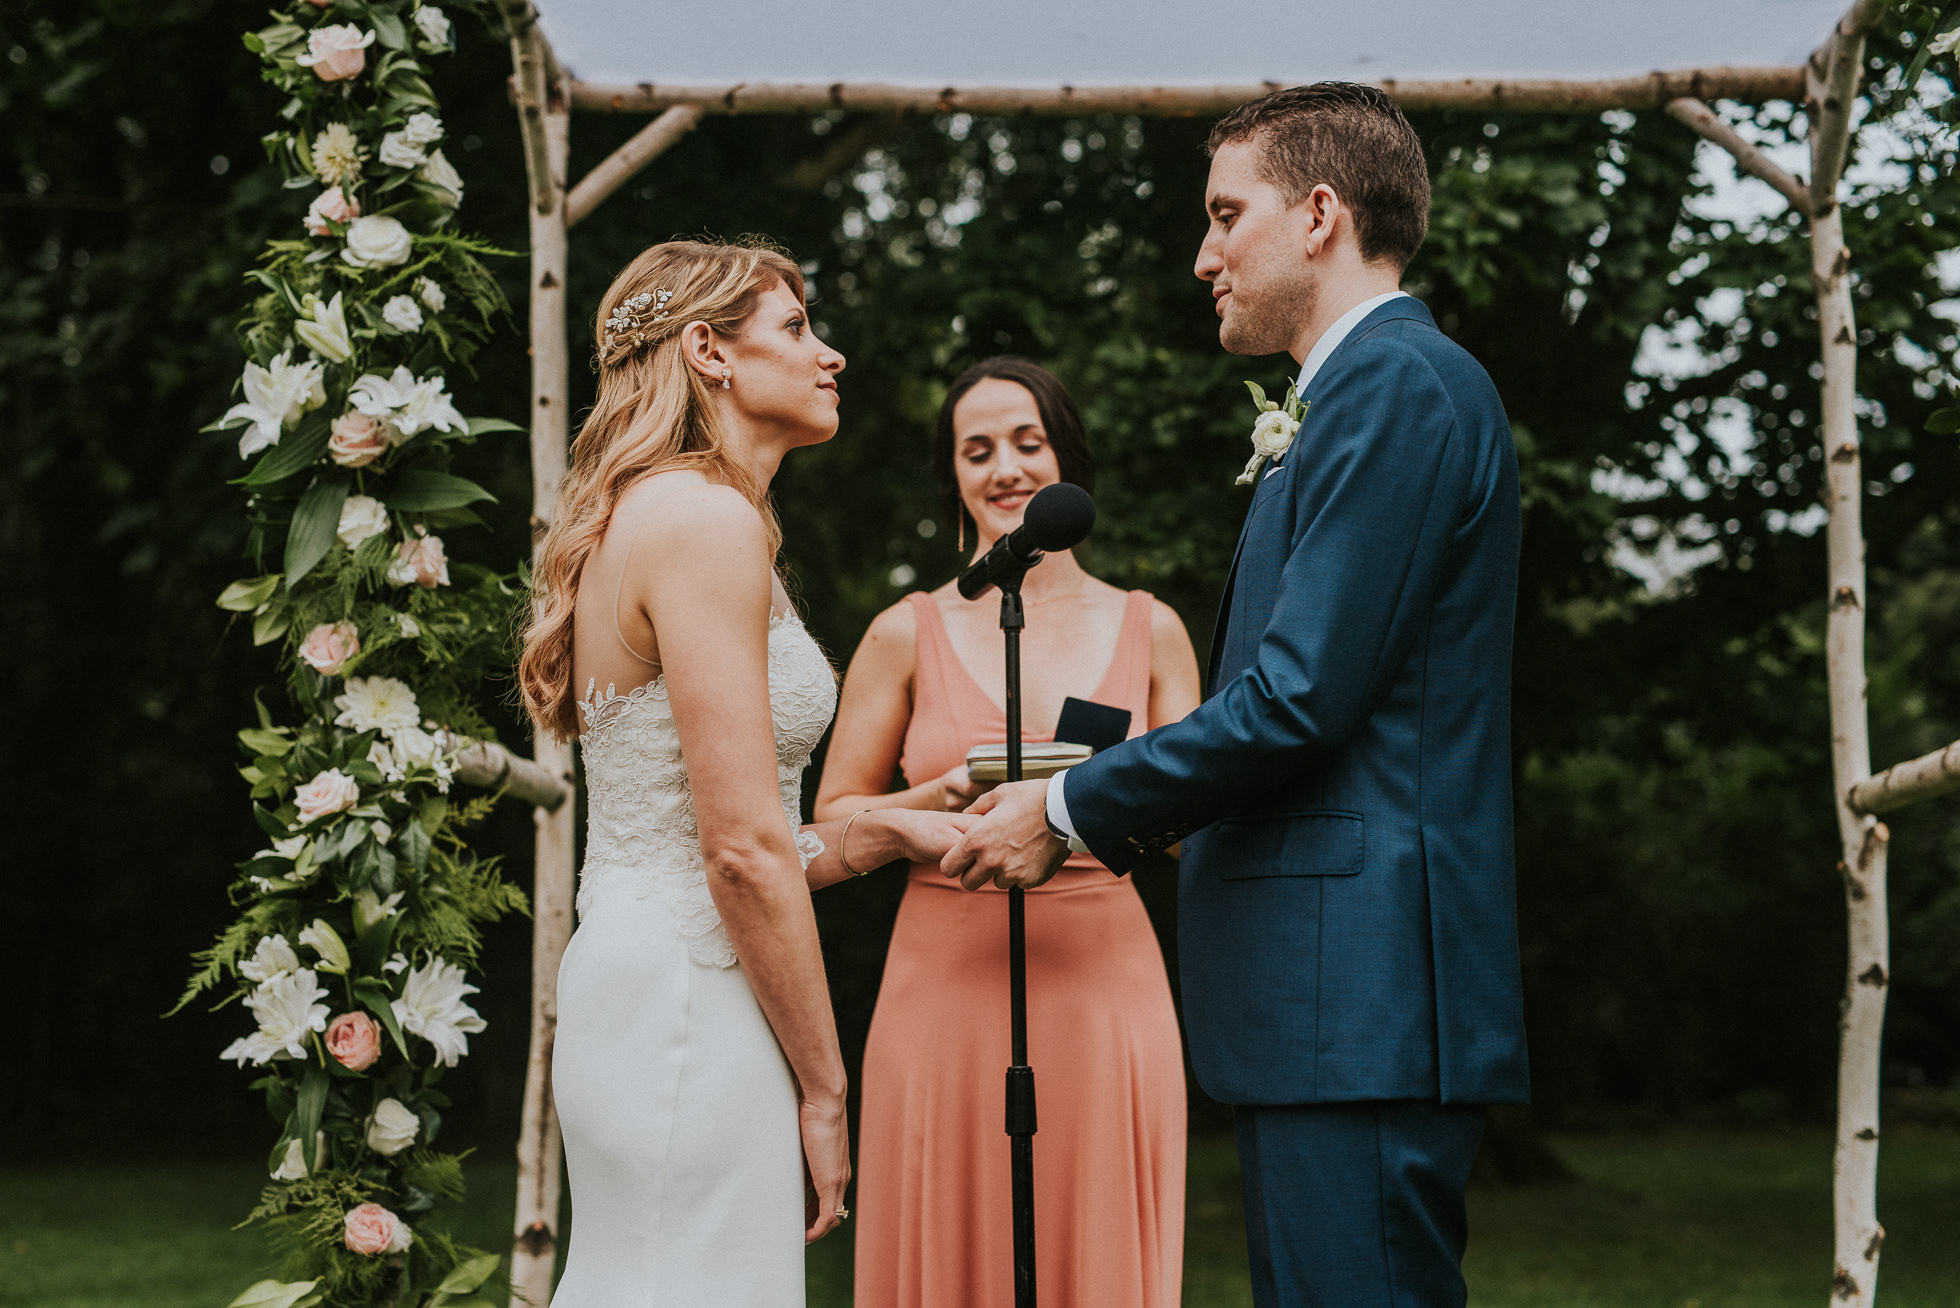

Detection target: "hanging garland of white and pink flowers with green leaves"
[178, 0, 525, 1308]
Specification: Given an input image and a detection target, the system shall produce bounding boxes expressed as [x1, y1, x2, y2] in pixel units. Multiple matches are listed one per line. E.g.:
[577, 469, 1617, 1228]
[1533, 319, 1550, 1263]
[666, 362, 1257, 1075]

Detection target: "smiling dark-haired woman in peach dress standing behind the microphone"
[815, 357, 1198, 1308]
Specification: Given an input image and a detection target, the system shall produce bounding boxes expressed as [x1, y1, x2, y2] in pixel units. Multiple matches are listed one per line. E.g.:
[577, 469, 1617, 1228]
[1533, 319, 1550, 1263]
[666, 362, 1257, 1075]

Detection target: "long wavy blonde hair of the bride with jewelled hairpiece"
[517, 237, 804, 739]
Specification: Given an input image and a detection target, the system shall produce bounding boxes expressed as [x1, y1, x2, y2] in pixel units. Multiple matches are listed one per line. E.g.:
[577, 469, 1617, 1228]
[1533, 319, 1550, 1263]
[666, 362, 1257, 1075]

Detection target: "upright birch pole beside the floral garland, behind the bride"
[498, 0, 578, 1308]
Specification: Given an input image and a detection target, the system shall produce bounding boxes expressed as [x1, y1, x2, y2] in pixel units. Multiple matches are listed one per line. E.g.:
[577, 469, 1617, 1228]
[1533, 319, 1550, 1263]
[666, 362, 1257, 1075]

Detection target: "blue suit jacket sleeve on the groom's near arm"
[1062, 337, 1472, 873]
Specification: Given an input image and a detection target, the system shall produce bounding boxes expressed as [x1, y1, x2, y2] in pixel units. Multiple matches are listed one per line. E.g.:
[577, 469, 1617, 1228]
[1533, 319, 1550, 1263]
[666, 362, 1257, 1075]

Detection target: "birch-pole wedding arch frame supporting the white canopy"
[496, 0, 1960, 1308]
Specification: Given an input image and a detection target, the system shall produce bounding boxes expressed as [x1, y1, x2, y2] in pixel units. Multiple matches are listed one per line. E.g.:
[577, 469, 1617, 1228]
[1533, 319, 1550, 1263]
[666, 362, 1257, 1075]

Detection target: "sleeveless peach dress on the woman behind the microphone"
[857, 590, 1184, 1308]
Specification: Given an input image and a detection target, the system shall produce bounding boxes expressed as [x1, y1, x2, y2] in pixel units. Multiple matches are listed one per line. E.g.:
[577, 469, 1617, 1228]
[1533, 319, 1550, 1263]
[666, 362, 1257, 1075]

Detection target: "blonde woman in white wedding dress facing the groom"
[519, 241, 970, 1308]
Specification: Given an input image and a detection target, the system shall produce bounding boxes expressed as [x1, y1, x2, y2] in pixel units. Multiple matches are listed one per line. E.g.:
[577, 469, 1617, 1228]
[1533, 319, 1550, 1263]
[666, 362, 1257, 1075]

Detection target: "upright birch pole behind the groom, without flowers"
[1807, 0, 1891, 1308]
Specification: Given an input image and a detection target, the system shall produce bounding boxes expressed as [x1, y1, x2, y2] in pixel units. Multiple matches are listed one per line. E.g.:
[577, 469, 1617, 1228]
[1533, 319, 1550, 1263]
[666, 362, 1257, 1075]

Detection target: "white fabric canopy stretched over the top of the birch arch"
[541, 0, 1846, 88]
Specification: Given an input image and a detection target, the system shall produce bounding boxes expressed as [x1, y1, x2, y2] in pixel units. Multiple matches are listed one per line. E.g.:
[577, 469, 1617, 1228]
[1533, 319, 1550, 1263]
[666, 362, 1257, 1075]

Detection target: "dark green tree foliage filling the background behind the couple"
[0, 0, 1960, 1153]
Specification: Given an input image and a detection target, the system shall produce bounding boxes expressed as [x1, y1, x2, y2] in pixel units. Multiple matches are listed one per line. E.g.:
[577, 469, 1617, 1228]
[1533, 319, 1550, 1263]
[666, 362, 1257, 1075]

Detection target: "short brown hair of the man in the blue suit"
[1205, 82, 1429, 271]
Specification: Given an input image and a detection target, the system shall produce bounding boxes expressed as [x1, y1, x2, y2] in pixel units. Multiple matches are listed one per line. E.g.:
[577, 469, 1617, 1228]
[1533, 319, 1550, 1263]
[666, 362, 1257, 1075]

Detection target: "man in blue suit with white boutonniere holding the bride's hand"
[945, 82, 1527, 1308]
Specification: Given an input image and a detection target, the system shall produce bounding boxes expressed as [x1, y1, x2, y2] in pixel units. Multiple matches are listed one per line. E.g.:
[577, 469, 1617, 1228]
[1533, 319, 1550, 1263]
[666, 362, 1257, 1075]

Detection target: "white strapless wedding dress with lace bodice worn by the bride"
[551, 616, 837, 1308]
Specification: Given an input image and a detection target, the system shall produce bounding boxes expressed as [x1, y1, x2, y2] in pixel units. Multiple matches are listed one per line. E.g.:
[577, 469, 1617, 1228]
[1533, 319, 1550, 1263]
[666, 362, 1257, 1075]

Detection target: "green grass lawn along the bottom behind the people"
[0, 1132, 1960, 1308]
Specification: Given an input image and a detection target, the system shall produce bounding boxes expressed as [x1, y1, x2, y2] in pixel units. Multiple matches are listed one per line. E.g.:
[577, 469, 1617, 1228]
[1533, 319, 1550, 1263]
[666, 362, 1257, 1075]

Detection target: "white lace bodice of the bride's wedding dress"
[578, 614, 837, 967]
